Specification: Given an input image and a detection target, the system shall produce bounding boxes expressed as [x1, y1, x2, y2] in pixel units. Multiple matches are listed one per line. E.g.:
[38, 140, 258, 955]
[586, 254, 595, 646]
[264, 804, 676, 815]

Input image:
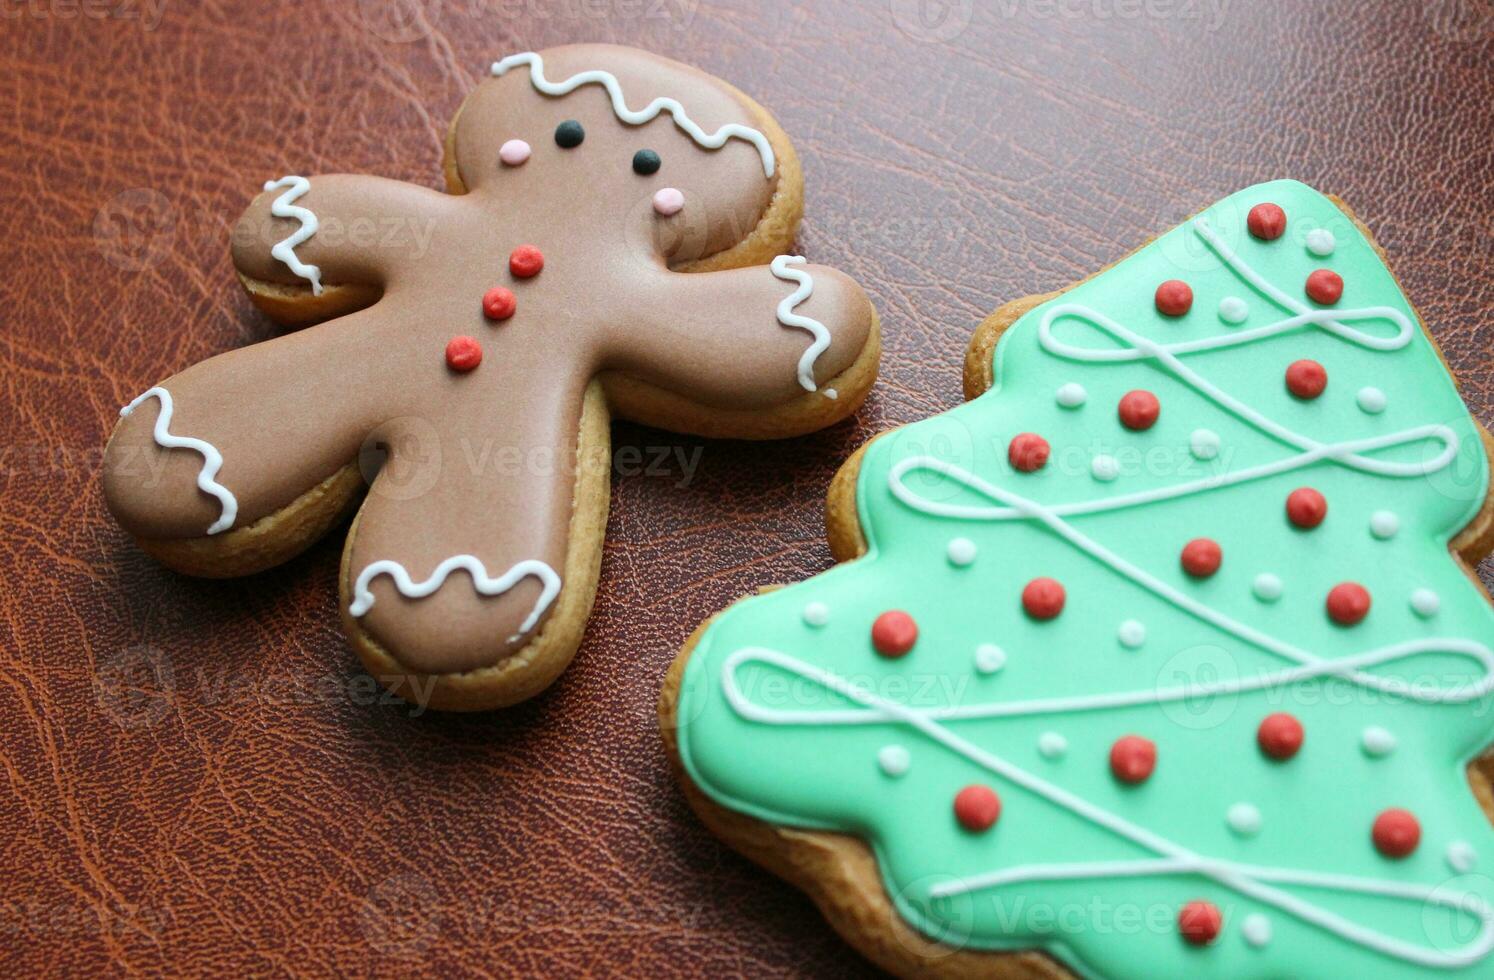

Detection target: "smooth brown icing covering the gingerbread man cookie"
[103, 45, 872, 672]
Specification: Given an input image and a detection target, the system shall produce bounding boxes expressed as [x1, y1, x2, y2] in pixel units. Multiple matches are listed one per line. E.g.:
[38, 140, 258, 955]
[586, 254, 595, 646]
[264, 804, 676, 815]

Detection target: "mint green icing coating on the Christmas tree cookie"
[678, 181, 1494, 977]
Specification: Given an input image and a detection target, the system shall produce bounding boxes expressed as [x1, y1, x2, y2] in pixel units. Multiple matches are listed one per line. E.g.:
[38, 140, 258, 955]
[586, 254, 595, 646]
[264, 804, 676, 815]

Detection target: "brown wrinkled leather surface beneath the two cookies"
[0, 0, 1494, 976]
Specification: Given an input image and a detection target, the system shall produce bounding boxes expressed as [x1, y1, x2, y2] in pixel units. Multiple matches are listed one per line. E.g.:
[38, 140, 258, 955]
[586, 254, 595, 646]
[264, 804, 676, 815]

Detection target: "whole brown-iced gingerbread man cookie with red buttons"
[103, 45, 878, 710]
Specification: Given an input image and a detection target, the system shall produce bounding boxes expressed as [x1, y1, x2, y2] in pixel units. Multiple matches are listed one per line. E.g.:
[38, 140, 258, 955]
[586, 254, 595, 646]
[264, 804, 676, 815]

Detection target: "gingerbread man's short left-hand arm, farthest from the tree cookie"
[232, 173, 451, 296]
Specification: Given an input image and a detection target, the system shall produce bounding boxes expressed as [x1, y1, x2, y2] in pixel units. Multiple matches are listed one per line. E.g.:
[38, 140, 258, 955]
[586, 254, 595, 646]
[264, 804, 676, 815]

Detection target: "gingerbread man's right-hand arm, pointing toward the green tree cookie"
[608, 255, 877, 418]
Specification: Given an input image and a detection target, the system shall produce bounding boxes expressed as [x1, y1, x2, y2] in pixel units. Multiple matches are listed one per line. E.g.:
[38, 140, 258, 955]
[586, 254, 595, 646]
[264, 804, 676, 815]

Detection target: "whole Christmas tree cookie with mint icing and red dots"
[662, 181, 1494, 980]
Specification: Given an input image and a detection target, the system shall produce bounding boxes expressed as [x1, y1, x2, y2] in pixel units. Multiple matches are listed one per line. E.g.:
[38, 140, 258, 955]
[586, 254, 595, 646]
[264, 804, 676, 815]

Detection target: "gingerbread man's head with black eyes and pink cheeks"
[448, 45, 792, 263]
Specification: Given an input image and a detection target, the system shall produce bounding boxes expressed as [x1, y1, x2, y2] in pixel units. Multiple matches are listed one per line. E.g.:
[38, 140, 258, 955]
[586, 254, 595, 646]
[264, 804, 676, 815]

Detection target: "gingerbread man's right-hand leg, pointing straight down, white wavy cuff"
[341, 376, 610, 710]
